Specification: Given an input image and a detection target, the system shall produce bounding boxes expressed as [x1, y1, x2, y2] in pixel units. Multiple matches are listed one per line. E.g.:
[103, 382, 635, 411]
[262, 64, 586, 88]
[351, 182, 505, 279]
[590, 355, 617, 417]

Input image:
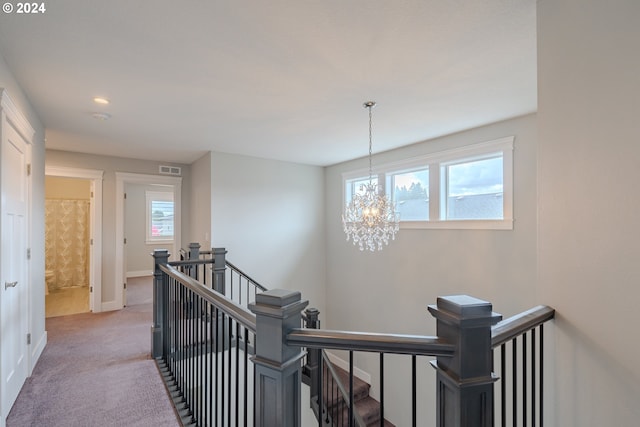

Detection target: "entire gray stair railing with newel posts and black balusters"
[152, 246, 554, 427]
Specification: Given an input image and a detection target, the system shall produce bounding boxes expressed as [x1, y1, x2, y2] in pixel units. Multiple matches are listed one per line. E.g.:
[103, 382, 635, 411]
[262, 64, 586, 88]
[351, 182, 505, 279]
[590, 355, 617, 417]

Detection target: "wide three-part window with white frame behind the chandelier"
[343, 137, 514, 229]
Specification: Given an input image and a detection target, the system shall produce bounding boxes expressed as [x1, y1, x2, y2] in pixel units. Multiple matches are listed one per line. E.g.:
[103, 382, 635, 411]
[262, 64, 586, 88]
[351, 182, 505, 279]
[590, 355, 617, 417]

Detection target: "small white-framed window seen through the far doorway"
[145, 191, 174, 243]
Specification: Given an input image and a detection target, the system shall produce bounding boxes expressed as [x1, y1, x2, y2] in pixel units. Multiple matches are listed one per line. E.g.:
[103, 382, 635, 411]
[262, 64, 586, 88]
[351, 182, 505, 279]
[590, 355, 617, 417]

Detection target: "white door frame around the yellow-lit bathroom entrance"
[44, 165, 104, 313]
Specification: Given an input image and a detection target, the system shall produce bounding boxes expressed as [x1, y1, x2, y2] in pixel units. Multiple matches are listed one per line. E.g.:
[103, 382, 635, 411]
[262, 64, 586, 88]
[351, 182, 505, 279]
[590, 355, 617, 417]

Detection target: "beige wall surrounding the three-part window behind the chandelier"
[321, 115, 538, 425]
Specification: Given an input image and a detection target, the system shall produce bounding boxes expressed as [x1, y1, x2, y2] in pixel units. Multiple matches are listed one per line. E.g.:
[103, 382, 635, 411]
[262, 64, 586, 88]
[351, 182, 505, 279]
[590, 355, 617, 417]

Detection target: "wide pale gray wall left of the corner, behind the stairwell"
[211, 153, 325, 318]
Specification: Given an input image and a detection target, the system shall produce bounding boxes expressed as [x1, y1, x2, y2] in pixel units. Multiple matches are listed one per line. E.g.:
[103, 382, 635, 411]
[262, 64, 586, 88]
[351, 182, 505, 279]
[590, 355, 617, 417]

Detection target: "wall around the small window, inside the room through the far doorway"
[124, 183, 173, 277]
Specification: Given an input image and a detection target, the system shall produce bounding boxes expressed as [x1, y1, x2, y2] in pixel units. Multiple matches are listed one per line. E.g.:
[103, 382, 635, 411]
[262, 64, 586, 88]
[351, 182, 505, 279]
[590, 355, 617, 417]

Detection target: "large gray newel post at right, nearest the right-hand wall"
[429, 295, 502, 427]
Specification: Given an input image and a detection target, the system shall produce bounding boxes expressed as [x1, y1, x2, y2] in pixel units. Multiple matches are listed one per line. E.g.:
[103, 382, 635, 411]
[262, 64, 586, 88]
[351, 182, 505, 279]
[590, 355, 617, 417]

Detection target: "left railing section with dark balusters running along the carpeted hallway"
[152, 250, 257, 426]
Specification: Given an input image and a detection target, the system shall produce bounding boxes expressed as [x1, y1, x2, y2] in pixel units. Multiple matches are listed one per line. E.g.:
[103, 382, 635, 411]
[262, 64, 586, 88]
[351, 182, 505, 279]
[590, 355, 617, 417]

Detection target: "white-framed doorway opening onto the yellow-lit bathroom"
[45, 166, 103, 317]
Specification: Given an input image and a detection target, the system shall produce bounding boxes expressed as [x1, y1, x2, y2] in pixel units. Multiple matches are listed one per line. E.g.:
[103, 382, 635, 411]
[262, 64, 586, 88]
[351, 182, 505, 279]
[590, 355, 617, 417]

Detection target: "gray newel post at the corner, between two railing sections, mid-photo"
[249, 289, 309, 427]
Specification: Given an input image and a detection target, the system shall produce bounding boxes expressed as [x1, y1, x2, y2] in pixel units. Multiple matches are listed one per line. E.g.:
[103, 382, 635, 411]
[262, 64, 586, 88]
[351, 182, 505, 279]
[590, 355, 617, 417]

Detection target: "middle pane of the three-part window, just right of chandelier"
[389, 168, 429, 221]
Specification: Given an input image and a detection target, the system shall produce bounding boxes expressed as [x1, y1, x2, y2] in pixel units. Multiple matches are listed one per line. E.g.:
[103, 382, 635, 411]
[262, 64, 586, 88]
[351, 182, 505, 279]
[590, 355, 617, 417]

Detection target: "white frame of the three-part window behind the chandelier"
[342, 136, 515, 230]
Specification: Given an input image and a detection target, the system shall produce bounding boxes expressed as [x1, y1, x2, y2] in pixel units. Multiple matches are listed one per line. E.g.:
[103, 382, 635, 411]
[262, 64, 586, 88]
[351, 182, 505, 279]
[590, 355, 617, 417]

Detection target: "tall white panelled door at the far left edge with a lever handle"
[0, 119, 29, 419]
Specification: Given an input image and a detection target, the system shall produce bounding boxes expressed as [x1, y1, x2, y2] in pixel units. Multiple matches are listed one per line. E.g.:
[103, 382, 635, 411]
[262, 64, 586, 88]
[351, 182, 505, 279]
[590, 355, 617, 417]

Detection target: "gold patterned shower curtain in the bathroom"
[45, 199, 89, 290]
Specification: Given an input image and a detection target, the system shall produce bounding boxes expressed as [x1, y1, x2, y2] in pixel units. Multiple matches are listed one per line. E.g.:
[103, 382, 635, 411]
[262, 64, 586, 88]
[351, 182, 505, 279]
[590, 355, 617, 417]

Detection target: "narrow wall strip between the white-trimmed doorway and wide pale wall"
[188, 152, 211, 250]
